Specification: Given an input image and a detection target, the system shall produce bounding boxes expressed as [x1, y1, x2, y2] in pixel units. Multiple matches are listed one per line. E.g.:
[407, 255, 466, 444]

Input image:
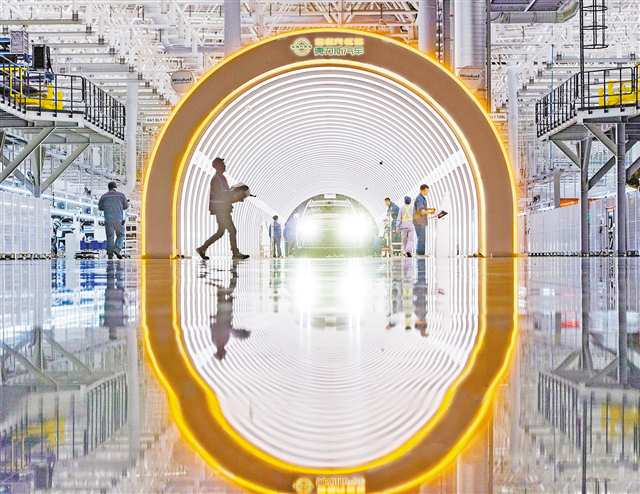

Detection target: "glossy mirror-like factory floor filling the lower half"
[0, 258, 640, 493]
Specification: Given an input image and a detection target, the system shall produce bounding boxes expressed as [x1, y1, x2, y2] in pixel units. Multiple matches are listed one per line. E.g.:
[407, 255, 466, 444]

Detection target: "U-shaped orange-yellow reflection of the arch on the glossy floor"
[144, 260, 515, 492]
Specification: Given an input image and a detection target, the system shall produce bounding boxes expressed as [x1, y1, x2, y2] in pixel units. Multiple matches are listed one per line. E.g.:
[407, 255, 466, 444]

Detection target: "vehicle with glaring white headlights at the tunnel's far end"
[297, 194, 376, 255]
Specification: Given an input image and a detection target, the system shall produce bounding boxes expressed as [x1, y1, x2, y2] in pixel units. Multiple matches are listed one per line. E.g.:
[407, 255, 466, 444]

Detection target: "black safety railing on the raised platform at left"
[0, 56, 126, 139]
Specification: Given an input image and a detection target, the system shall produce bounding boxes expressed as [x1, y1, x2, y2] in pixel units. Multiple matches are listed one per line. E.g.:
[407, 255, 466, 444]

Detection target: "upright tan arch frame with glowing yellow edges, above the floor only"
[142, 29, 516, 258]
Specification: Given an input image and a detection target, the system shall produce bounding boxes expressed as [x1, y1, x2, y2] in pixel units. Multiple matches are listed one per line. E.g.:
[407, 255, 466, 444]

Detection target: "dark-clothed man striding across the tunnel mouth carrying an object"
[196, 158, 249, 261]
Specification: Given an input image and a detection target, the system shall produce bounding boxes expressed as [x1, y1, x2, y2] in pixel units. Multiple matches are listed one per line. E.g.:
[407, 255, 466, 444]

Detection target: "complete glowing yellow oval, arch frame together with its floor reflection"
[141, 29, 516, 492]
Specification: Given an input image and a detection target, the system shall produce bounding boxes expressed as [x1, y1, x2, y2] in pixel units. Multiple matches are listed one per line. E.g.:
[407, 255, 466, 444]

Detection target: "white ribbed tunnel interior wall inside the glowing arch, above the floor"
[179, 67, 478, 255]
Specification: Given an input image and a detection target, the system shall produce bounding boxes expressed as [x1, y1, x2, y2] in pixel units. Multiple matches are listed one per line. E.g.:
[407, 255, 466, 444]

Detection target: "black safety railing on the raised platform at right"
[536, 65, 640, 137]
